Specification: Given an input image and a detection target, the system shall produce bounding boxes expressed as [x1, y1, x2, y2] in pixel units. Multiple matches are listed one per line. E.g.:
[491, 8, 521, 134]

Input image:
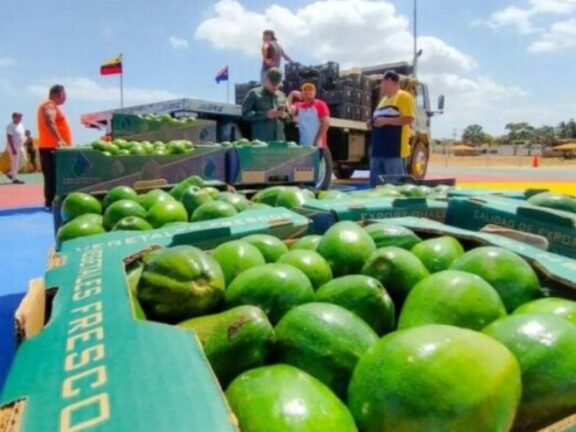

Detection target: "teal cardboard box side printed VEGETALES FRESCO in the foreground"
[0, 209, 308, 432]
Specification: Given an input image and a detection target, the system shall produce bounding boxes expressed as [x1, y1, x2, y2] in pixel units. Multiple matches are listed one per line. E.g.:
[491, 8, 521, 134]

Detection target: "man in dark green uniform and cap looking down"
[242, 68, 288, 141]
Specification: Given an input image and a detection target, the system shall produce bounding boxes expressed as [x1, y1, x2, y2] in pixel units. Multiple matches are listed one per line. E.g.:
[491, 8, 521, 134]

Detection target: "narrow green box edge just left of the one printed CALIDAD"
[296, 198, 448, 234]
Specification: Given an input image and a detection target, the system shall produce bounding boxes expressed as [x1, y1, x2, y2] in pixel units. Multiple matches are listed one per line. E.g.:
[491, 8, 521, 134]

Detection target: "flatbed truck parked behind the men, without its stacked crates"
[81, 62, 444, 189]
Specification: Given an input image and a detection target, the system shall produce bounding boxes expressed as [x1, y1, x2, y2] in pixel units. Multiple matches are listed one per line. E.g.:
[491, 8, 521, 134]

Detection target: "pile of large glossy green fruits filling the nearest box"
[127, 221, 576, 432]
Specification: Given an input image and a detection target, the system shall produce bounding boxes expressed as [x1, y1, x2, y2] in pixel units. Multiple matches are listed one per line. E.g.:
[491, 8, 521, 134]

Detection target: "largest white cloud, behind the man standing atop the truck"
[195, 0, 475, 71]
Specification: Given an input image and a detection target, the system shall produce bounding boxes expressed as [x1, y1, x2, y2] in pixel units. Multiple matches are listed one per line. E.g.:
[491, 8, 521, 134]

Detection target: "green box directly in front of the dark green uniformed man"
[226, 142, 320, 185]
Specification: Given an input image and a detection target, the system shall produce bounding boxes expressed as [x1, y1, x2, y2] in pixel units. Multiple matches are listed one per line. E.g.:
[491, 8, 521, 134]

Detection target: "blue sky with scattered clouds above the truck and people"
[0, 0, 576, 144]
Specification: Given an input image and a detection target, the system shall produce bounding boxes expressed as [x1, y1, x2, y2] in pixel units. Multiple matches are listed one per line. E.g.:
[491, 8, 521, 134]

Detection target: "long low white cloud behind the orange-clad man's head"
[27, 77, 181, 105]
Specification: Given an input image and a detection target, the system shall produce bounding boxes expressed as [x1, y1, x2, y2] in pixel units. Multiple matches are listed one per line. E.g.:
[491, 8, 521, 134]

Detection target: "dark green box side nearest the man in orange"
[56, 146, 226, 196]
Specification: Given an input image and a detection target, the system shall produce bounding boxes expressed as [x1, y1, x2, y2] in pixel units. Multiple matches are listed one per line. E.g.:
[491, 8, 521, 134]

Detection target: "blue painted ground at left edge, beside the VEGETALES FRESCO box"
[0, 207, 54, 389]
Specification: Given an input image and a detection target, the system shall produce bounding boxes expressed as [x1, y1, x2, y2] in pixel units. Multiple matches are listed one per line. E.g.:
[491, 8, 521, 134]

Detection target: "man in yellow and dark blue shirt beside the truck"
[369, 71, 416, 187]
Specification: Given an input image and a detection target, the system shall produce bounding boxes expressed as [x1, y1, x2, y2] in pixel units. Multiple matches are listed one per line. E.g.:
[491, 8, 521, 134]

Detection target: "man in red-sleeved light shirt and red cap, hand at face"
[288, 83, 330, 149]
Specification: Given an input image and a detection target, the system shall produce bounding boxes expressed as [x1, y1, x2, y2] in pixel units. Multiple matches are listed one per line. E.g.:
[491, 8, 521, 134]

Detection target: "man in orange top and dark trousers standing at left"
[37, 84, 72, 209]
